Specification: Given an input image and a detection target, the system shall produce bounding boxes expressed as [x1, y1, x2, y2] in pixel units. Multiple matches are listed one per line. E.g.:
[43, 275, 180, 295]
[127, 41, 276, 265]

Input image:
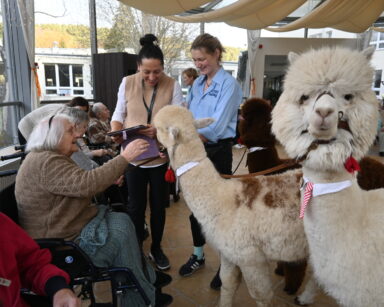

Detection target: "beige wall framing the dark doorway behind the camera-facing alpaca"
[250, 37, 357, 97]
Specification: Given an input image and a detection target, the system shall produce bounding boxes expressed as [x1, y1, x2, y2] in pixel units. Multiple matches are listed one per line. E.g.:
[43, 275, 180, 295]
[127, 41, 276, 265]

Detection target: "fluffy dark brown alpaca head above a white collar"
[239, 98, 275, 148]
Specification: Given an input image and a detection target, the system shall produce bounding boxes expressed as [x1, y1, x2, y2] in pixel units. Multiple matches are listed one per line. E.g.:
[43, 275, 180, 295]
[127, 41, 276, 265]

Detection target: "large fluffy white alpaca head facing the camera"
[272, 48, 378, 171]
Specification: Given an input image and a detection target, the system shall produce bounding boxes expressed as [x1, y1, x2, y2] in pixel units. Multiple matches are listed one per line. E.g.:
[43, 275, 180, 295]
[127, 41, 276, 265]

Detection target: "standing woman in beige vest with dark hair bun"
[111, 34, 183, 276]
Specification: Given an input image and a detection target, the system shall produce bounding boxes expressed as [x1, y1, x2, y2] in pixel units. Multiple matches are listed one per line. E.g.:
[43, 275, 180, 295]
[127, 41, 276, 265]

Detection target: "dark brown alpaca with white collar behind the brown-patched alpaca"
[238, 98, 307, 294]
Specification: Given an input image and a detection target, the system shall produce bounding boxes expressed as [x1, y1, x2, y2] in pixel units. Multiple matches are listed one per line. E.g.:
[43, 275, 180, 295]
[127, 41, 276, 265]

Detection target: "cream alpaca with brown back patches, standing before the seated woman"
[154, 106, 308, 307]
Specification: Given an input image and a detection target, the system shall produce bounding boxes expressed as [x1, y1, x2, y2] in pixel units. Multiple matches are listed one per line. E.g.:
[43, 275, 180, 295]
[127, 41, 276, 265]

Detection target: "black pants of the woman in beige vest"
[125, 164, 169, 250]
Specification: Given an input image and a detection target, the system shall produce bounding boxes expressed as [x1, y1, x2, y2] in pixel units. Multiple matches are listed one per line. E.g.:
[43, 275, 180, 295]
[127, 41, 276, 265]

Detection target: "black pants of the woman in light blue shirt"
[189, 140, 232, 247]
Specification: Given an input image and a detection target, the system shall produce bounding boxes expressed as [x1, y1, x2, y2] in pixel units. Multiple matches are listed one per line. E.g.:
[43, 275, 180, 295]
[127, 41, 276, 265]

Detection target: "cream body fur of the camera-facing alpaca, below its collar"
[304, 182, 384, 307]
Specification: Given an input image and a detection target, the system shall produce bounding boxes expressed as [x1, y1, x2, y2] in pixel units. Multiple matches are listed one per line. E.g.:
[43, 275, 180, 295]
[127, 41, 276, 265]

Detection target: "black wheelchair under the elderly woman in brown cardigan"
[0, 150, 151, 307]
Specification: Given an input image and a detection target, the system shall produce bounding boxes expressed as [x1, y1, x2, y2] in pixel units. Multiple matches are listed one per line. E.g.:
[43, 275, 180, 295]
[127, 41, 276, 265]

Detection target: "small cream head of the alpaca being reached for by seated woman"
[154, 106, 214, 149]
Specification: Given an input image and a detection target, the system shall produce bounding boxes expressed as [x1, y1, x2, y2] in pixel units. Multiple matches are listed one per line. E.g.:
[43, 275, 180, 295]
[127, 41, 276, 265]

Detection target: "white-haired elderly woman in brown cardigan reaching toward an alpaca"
[15, 114, 172, 306]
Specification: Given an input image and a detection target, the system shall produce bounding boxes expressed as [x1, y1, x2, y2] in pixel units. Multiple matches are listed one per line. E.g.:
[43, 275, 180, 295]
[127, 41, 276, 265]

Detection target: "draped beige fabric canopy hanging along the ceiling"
[120, 0, 384, 33]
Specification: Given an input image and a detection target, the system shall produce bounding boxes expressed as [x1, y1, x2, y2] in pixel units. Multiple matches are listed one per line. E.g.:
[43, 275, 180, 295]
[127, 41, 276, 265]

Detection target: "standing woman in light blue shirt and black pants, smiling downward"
[179, 33, 242, 289]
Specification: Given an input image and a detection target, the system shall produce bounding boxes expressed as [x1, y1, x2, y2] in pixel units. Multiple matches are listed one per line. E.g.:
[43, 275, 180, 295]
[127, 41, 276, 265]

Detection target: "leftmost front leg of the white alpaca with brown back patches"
[219, 256, 241, 307]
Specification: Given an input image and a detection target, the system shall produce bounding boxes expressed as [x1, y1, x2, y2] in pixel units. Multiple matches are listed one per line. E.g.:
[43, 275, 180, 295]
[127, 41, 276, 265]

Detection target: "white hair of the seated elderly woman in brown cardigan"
[26, 113, 73, 151]
